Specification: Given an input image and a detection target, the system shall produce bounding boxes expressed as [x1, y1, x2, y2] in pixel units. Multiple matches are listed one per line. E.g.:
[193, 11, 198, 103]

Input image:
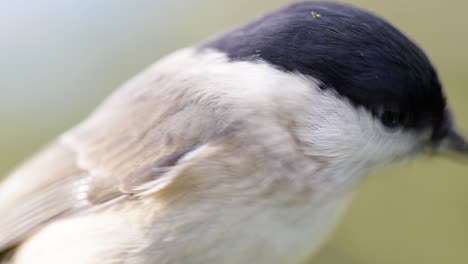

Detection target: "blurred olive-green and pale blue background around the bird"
[0, 0, 468, 264]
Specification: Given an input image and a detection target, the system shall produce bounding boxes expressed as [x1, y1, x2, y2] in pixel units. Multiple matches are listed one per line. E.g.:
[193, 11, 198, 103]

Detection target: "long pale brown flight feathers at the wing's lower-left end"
[0, 143, 84, 251]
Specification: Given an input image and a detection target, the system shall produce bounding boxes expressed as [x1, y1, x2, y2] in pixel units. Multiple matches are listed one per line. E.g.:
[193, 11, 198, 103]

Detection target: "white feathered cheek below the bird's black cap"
[298, 89, 421, 167]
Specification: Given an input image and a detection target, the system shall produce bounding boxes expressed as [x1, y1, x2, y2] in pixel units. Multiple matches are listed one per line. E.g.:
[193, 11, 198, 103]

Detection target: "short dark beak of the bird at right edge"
[438, 128, 468, 161]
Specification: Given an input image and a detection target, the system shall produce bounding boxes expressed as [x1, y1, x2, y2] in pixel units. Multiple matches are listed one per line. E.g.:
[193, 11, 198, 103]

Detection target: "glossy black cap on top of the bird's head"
[201, 2, 448, 136]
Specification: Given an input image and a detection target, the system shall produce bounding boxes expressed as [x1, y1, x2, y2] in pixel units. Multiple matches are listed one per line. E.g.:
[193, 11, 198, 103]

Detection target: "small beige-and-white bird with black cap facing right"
[0, 2, 468, 264]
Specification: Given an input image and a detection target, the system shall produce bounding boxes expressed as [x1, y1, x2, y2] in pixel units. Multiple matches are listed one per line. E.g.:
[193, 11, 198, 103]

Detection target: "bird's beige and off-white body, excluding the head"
[0, 50, 362, 264]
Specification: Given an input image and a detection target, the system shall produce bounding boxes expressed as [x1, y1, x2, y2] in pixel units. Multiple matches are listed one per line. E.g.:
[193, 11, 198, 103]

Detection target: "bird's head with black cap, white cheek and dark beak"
[203, 2, 468, 171]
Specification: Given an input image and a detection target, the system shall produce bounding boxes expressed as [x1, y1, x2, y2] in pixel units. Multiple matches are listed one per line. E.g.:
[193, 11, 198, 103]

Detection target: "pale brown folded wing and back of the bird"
[0, 50, 229, 252]
